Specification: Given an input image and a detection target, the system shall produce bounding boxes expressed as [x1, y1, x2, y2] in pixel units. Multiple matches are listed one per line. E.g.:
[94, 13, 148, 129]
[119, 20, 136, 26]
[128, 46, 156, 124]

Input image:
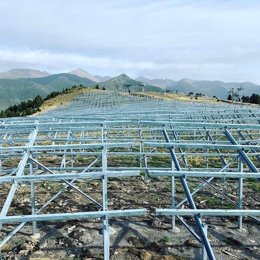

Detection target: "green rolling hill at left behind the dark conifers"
[0, 73, 94, 110]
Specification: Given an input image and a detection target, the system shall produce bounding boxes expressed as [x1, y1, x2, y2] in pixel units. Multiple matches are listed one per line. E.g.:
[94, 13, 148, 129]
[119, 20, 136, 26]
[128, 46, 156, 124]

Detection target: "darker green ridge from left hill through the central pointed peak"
[0, 71, 162, 110]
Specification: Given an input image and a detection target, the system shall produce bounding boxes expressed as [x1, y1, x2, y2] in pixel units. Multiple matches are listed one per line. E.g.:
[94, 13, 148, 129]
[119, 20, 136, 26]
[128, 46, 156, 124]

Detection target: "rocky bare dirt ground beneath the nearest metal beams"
[0, 177, 260, 260]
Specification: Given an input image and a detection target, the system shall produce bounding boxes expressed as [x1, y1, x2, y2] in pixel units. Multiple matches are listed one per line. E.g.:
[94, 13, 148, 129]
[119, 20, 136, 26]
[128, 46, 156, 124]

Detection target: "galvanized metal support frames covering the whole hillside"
[0, 91, 260, 259]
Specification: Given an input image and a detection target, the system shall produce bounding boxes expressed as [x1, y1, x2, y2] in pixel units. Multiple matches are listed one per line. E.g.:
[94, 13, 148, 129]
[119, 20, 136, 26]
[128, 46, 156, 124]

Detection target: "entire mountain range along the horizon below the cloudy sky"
[0, 69, 260, 110]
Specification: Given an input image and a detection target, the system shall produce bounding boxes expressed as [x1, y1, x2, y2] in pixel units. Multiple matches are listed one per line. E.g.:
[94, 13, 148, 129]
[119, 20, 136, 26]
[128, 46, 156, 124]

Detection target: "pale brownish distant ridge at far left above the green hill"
[0, 69, 50, 79]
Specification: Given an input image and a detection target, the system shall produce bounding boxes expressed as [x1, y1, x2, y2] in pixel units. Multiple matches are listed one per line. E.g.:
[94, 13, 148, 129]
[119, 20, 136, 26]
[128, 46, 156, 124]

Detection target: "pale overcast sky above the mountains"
[0, 0, 260, 83]
